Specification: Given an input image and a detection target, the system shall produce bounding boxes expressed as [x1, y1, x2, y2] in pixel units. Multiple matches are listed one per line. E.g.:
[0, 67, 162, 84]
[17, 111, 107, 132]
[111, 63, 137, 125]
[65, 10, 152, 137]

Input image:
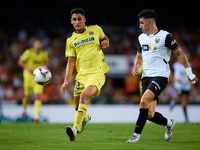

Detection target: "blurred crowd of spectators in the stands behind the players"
[0, 25, 200, 104]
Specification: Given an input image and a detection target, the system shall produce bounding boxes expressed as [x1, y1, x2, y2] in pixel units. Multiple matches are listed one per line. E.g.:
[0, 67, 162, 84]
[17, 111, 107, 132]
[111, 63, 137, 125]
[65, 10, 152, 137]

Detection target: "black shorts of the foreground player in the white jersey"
[142, 77, 168, 101]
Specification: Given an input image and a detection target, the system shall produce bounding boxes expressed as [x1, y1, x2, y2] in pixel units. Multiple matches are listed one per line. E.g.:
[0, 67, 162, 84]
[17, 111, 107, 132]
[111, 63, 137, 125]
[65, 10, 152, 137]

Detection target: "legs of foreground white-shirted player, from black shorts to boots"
[127, 77, 175, 143]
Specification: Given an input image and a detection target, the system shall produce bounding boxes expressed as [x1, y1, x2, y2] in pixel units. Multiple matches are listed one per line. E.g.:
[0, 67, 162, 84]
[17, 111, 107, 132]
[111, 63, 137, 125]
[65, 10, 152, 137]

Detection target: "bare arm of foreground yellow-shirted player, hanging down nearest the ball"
[60, 57, 76, 95]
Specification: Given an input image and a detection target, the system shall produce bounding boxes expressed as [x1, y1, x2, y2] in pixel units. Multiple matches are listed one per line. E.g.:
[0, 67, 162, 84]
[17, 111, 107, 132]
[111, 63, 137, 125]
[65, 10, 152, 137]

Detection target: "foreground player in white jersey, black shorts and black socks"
[126, 9, 198, 143]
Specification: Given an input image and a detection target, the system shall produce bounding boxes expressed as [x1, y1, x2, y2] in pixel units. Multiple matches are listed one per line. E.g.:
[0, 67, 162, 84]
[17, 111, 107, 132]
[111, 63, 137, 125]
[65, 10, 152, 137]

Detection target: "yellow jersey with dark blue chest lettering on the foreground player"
[65, 25, 109, 73]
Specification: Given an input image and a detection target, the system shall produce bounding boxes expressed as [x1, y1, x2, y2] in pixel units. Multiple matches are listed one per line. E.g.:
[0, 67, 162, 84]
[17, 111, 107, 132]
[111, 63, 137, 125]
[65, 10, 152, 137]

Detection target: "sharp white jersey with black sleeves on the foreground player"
[137, 30, 179, 78]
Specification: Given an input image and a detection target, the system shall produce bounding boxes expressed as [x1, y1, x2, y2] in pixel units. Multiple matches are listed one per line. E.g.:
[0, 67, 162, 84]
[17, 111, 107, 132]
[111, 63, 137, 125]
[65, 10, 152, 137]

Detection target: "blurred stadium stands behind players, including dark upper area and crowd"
[0, 0, 200, 122]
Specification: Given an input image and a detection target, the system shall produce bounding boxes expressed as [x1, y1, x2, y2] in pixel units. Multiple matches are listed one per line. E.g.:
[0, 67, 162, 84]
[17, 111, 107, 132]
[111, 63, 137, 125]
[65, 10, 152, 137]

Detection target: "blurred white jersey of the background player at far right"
[173, 62, 191, 91]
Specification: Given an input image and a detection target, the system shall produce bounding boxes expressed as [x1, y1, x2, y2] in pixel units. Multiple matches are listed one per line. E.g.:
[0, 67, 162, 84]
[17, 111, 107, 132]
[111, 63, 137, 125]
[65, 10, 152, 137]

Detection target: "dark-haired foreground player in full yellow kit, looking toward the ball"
[60, 8, 109, 141]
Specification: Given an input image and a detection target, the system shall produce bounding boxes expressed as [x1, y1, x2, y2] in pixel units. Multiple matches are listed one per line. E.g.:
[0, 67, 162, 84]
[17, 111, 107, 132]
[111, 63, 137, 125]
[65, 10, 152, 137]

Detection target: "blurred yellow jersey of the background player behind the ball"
[20, 48, 49, 78]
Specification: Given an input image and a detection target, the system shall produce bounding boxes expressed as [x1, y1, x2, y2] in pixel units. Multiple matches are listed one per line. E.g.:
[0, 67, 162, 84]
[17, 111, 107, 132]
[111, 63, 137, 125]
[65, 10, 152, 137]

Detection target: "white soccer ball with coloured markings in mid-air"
[33, 67, 52, 85]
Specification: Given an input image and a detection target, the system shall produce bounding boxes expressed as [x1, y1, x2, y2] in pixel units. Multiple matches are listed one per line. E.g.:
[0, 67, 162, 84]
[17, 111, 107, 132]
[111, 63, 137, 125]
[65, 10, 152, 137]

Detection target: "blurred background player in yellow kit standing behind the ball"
[18, 40, 49, 123]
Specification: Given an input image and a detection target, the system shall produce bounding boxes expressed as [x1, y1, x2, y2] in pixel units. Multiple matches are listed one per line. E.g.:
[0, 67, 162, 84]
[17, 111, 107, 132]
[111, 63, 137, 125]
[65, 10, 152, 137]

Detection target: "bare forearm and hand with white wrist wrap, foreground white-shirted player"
[174, 47, 198, 84]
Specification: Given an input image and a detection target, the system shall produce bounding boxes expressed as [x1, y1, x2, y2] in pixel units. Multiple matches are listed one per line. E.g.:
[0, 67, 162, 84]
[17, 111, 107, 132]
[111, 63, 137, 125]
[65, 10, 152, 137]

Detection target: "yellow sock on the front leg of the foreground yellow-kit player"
[74, 103, 87, 129]
